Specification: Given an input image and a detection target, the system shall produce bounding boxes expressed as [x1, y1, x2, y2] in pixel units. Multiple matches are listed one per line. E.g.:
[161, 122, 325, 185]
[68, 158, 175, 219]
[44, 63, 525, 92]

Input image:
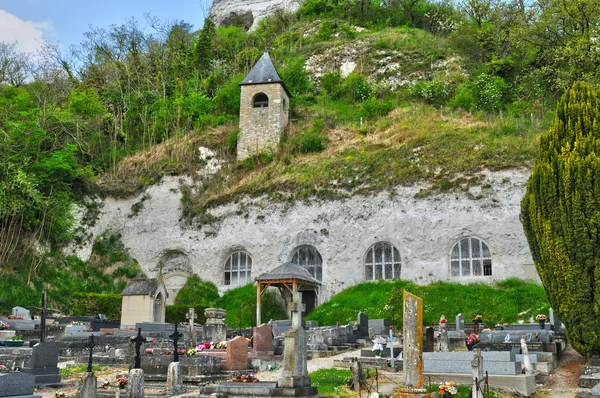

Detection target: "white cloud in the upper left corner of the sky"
[0, 9, 53, 53]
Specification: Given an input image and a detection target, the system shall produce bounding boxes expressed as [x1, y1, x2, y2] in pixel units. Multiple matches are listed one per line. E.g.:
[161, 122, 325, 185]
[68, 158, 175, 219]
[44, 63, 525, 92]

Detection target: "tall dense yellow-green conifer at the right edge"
[521, 82, 600, 356]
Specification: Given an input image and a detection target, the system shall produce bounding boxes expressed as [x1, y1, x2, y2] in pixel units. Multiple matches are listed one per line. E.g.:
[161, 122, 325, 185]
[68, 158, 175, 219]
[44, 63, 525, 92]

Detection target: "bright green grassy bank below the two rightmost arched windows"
[306, 279, 549, 328]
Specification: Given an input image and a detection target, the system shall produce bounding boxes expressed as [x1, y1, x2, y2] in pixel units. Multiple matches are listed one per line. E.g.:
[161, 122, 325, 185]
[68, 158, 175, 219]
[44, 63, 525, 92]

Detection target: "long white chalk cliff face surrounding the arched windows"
[71, 166, 539, 302]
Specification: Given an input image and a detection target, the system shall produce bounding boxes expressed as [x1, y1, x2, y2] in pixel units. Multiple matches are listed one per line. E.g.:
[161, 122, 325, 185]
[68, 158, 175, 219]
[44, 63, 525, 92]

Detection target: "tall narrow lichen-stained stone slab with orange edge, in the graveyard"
[402, 290, 425, 393]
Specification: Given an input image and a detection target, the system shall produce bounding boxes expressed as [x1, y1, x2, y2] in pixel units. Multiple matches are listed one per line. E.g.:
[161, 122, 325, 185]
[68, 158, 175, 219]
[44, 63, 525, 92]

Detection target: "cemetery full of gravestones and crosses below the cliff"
[0, 280, 580, 398]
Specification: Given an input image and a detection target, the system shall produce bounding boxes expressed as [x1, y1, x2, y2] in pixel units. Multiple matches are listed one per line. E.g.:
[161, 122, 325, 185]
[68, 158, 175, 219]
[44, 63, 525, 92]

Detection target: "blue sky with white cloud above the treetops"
[0, 0, 212, 53]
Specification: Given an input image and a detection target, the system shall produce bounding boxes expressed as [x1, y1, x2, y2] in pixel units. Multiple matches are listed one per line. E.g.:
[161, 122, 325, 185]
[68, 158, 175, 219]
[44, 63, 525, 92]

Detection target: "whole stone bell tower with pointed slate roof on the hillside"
[237, 51, 290, 160]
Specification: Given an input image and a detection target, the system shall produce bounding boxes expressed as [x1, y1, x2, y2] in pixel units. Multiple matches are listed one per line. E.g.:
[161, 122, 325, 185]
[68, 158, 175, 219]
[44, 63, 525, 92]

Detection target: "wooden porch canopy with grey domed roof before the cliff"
[255, 263, 321, 326]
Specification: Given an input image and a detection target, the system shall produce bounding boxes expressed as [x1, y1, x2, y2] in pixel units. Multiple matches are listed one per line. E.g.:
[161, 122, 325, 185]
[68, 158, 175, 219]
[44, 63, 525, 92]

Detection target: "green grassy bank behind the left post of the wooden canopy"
[215, 284, 287, 328]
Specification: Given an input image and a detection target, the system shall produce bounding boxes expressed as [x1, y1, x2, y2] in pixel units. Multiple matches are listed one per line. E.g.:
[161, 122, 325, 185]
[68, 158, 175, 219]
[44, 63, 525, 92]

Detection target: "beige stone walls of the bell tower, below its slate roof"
[237, 83, 290, 160]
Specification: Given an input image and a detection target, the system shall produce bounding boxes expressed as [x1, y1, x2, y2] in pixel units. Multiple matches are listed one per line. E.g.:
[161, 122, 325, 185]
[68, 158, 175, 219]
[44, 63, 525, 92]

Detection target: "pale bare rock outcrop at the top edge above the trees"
[209, 0, 303, 30]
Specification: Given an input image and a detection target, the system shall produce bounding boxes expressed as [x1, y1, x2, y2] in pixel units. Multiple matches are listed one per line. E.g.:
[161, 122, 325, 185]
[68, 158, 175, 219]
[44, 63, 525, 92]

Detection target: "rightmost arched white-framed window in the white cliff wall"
[450, 238, 492, 276]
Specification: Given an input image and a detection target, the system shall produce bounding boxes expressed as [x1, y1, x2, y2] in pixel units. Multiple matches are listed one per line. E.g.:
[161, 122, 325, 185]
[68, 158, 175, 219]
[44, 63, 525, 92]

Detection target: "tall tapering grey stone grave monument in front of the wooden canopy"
[277, 292, 312, 388]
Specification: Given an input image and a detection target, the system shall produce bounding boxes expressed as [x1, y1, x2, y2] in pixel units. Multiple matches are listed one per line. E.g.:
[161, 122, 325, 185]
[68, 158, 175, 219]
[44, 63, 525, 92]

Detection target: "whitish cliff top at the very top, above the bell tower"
[209, 0, 302, 30]
